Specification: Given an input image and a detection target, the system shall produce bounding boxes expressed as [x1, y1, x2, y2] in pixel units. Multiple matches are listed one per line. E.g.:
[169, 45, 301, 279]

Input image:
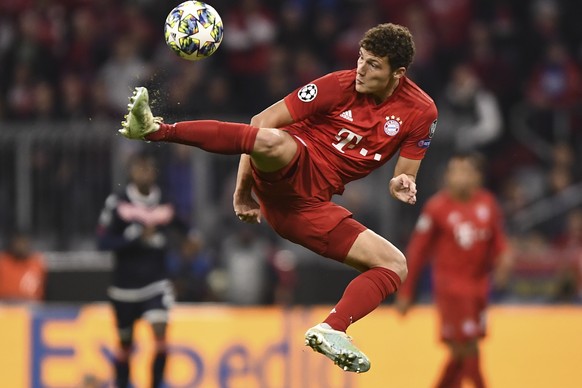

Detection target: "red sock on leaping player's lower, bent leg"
[324, 267, 400, 332]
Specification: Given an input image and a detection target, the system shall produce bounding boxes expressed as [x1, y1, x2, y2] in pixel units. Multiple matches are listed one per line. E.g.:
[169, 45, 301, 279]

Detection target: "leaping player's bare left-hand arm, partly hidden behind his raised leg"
[233, 100, 294, 224]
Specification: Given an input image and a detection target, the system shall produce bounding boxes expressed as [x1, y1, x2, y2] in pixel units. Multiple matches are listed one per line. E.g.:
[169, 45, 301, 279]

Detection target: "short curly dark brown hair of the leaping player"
[360, 23, 415, 69]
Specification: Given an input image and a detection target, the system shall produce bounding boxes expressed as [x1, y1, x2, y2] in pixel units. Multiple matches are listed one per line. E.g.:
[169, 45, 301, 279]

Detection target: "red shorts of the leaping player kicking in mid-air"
[253, 138, 367, 262]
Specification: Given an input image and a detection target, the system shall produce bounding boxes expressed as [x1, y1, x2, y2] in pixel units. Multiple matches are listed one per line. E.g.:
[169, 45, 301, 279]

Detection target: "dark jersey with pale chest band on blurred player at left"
[98, 184, 187, 289]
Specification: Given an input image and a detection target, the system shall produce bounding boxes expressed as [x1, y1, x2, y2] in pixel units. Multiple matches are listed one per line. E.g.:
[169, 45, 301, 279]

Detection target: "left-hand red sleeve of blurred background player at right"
[398, 202, 438, 299]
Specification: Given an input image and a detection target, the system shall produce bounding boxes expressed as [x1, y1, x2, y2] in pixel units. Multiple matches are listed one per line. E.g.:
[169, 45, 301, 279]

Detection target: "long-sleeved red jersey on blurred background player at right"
[399, 190, 507, 297]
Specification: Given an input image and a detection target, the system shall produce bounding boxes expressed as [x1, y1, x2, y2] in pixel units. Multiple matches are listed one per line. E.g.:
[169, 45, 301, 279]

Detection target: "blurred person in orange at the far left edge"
[0, 232, 46, 302]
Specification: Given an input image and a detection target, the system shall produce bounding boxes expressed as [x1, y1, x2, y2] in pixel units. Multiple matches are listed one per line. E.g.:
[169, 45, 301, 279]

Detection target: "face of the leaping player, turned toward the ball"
[356, 47, 405, 102]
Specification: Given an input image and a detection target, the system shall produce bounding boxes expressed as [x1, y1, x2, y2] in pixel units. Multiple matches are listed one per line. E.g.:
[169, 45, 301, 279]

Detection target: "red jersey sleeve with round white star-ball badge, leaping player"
[284, 73, 343, 121]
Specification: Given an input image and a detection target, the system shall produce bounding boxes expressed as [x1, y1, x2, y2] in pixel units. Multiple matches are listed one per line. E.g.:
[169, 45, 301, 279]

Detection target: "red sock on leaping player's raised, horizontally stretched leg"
[145, 120, 259, 155]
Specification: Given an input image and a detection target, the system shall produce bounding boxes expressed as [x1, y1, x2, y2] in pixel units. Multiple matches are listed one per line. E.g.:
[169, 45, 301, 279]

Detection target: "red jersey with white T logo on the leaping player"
[282, 69, 437, 194]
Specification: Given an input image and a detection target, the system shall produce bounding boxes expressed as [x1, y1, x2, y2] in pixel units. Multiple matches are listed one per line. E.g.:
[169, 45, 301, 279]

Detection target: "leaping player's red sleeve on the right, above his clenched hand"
[400, 103, 438, 160]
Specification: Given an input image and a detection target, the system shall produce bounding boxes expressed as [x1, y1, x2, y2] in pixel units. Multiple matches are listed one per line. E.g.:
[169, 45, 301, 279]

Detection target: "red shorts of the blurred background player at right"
[435, 293, 487, 342]
